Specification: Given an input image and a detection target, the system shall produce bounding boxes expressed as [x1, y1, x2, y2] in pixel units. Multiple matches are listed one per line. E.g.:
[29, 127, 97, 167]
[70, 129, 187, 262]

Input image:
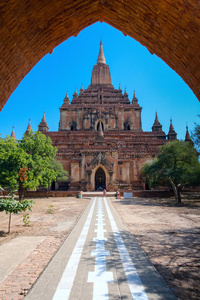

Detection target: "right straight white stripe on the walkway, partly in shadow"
[104, 198, 148, 300]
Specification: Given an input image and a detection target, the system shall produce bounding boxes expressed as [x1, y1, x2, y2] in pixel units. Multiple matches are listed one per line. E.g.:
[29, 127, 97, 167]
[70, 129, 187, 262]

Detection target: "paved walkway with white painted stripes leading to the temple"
[26, 197, 176, 300]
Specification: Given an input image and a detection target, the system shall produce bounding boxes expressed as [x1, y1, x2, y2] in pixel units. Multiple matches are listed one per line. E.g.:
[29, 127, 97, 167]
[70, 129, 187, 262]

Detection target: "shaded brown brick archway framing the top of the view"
[0, 0, 200, 109]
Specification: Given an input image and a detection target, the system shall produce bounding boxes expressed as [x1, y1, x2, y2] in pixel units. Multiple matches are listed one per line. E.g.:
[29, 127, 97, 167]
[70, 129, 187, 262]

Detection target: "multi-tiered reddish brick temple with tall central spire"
[39, 42, 176, 191]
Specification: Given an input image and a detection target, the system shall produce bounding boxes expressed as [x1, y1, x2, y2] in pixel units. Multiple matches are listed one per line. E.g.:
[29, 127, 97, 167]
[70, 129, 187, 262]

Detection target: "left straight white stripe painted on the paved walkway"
[53, 197, 96, 300]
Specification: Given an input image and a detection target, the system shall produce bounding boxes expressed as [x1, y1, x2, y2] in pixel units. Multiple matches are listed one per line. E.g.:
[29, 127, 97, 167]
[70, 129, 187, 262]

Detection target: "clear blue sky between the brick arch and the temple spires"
[0, 22, 200, 139]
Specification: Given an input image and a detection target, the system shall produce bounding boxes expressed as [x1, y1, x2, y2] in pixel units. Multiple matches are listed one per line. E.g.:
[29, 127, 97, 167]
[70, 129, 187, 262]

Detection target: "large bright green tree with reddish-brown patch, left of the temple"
[0, 131, 57, 199]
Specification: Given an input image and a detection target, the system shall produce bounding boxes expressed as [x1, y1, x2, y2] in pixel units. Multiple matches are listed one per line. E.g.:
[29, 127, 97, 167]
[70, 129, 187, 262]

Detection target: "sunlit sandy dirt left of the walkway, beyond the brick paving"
[0, 197, 89, 245]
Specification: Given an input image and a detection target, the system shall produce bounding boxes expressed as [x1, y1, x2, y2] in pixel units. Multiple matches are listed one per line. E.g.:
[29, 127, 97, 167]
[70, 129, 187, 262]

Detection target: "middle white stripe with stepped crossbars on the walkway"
[88, 198, 113, 300]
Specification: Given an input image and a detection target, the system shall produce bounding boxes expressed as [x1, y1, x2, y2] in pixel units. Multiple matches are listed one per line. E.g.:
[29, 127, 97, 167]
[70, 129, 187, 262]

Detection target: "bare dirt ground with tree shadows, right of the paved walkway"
[112, 196, 200, 300]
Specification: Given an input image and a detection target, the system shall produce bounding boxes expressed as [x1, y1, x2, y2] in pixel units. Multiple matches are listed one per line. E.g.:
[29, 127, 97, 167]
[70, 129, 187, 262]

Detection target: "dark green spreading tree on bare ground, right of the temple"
[142, 141, 200, 203]
